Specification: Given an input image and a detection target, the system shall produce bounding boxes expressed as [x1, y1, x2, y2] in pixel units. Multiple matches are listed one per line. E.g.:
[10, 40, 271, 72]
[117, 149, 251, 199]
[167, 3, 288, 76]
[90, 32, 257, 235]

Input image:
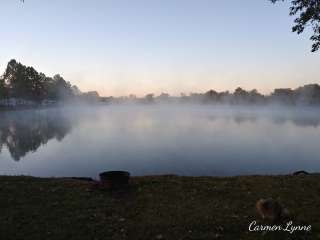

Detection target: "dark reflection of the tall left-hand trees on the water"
[0, 111, 71, 161]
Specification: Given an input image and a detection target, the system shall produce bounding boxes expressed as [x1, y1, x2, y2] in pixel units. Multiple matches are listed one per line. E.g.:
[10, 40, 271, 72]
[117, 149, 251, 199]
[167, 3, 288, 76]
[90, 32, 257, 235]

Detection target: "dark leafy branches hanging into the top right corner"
[270, 0, 320, 52]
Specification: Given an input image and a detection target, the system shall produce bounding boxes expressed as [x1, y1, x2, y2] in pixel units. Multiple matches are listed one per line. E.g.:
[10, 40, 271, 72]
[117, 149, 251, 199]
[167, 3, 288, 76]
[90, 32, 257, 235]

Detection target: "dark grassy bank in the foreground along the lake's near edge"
[0, 175, 320, 240]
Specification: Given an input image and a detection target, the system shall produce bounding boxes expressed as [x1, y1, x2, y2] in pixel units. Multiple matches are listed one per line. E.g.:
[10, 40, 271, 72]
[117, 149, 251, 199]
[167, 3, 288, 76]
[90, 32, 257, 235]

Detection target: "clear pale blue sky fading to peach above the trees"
[0, 0, 320, 96]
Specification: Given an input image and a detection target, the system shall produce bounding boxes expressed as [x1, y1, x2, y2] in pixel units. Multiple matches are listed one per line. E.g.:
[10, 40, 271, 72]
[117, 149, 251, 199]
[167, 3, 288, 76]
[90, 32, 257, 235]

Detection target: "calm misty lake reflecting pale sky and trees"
[0, 104, 320, 178]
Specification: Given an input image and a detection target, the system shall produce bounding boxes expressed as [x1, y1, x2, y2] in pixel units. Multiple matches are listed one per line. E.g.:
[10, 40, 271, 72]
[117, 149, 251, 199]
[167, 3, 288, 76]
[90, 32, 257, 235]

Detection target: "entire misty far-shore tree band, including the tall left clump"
[0, 59, 320, 109]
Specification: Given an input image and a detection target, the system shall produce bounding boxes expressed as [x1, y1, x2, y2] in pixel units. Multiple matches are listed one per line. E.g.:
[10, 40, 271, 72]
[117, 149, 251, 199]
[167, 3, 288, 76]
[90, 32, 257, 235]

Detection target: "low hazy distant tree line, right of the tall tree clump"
[111, 84, 320, 106]
